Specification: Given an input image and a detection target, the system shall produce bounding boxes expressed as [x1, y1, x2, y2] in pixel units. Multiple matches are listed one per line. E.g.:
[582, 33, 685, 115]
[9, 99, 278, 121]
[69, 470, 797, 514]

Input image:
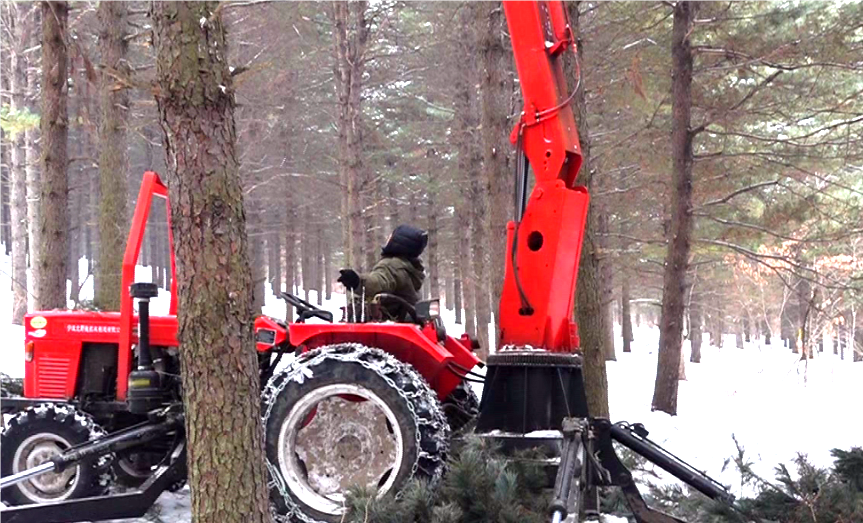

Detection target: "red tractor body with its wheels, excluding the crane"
[0, 172, 479, 520]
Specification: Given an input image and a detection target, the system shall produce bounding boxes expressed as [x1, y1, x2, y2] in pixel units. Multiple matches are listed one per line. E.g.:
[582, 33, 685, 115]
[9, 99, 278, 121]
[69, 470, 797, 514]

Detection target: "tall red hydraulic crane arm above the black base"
[499, 0, 589, 352]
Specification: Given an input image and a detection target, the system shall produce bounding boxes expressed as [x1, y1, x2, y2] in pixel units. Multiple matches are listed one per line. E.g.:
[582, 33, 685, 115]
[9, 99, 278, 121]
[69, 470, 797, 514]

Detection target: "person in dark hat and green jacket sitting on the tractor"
[337, 225, 428, 321]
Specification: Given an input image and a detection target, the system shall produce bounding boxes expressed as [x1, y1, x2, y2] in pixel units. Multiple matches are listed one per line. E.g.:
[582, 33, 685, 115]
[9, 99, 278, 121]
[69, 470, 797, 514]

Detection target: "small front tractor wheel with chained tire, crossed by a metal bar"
[0, 404, 111, 505]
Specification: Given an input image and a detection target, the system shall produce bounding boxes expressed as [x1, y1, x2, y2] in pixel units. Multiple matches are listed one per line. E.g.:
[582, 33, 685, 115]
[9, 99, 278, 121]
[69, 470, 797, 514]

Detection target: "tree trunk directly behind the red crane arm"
[566, 0, 614, 418]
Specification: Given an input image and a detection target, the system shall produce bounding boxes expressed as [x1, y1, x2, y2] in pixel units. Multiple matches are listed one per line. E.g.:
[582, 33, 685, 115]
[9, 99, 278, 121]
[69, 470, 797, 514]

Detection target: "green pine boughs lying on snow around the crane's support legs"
[344, 437, 863, 523]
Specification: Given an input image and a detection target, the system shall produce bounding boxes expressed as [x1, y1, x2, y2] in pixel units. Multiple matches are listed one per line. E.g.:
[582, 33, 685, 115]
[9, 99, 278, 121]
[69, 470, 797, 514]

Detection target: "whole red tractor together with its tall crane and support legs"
[0, 0, 744, 523]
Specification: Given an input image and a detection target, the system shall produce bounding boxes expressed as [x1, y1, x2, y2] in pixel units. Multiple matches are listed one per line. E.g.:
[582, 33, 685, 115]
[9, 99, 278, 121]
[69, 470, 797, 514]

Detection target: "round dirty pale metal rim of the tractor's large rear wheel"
[278, 384, 404, 515]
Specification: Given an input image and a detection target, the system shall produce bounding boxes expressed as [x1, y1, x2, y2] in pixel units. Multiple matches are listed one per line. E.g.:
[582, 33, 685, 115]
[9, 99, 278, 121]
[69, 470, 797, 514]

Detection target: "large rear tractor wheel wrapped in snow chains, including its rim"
[262, 344, 449, 523]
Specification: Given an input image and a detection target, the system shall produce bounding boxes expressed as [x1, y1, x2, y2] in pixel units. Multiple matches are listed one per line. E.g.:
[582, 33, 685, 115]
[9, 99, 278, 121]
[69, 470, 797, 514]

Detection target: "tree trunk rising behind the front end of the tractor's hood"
[36, 0, 69, 310]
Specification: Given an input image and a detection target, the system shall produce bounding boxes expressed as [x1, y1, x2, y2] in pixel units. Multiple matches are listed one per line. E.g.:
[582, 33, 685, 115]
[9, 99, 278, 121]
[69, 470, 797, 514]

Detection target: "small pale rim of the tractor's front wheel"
[12, 432, 80, 503]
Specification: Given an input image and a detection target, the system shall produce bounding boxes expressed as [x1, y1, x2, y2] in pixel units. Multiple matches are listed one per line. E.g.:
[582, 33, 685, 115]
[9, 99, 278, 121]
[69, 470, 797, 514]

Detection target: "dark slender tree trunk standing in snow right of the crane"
[652, 0, 698, 415]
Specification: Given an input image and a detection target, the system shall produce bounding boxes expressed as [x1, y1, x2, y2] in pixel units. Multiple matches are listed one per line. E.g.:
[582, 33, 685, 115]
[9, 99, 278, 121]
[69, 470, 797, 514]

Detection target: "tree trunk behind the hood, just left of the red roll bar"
[95, 0, 131, 311]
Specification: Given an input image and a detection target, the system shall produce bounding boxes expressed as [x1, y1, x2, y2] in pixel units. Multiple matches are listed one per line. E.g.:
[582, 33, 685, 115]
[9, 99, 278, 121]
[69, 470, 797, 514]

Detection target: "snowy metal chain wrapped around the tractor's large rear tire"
[261, 343, 449, 523]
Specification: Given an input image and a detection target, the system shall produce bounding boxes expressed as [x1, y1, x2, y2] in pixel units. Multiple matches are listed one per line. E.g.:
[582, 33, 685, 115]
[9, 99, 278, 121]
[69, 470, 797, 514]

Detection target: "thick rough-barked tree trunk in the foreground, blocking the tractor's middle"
[152, 0, 271, 523]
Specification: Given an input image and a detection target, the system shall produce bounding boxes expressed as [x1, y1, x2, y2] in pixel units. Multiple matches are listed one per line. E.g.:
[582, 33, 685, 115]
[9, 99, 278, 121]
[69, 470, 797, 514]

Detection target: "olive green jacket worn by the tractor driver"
[360, 257, 425, 317]
